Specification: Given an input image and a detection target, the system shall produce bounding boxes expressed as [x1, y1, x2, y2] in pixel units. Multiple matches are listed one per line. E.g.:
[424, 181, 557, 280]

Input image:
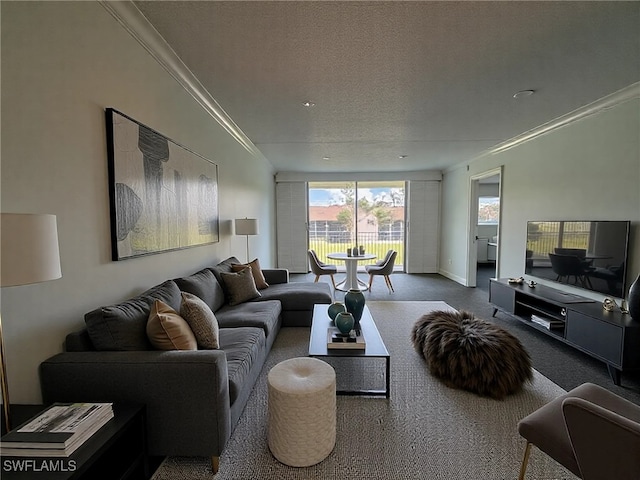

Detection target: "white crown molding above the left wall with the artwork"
[100, 0, 265, 160]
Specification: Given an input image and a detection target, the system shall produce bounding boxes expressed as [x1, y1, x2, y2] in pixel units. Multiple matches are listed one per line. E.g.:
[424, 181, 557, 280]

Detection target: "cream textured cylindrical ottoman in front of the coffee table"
[267, 357, 336, 467]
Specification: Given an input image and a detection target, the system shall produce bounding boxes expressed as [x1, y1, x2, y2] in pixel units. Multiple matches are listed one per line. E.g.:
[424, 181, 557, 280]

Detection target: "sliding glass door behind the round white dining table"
[308, 181, 406, 270]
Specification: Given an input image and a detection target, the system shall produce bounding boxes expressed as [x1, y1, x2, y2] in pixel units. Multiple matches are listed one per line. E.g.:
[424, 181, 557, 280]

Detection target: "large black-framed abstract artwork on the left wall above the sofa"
[105, 108, 220, 260]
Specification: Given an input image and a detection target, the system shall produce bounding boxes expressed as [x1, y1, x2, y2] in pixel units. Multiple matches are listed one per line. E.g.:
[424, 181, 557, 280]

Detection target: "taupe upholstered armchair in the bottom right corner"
[518, 383, 640, 480]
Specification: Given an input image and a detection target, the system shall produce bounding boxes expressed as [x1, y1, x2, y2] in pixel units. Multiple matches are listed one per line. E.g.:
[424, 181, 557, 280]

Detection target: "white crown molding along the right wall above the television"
[488, 82, 640, 157]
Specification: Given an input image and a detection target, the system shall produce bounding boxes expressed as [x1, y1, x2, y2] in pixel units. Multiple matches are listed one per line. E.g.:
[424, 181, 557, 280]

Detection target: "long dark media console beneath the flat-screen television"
[489, 279, 640, 385]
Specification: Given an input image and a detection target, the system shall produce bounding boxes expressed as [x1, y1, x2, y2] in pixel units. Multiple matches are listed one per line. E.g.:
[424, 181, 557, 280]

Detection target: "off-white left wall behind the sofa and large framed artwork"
[0, 2, 275, 403]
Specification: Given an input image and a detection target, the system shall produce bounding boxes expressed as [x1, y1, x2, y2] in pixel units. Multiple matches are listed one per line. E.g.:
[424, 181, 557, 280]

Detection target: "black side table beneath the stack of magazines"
[0, 404, 150, 480]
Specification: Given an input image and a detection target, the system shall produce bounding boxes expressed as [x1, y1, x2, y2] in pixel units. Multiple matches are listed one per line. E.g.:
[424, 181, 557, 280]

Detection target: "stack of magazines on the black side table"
[0, 403, 113, 457]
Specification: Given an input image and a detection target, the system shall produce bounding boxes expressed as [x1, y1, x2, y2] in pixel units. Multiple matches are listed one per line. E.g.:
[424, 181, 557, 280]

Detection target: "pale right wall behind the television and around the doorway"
[440, 96, 640, 299]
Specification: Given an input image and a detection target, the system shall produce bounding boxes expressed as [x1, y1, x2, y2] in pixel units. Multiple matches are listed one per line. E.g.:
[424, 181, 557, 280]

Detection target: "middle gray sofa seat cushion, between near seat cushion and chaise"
[216, 300, 282, 336]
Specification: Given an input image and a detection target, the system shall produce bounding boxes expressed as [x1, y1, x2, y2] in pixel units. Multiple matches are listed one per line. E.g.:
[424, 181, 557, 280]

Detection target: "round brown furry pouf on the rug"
[411, 311, 533, 399]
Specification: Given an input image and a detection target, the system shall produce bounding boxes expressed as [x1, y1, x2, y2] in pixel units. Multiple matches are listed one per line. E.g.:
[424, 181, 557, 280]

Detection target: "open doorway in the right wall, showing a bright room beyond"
[467, 168, 502, 291]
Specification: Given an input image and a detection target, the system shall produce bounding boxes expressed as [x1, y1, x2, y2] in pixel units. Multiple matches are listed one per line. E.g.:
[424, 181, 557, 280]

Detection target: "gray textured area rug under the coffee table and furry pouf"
[153, 301, 577, 480]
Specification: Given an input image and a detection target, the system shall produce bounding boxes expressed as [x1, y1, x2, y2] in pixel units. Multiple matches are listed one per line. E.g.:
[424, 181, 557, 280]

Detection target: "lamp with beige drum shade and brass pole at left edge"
[0, 213, 62, 432]
